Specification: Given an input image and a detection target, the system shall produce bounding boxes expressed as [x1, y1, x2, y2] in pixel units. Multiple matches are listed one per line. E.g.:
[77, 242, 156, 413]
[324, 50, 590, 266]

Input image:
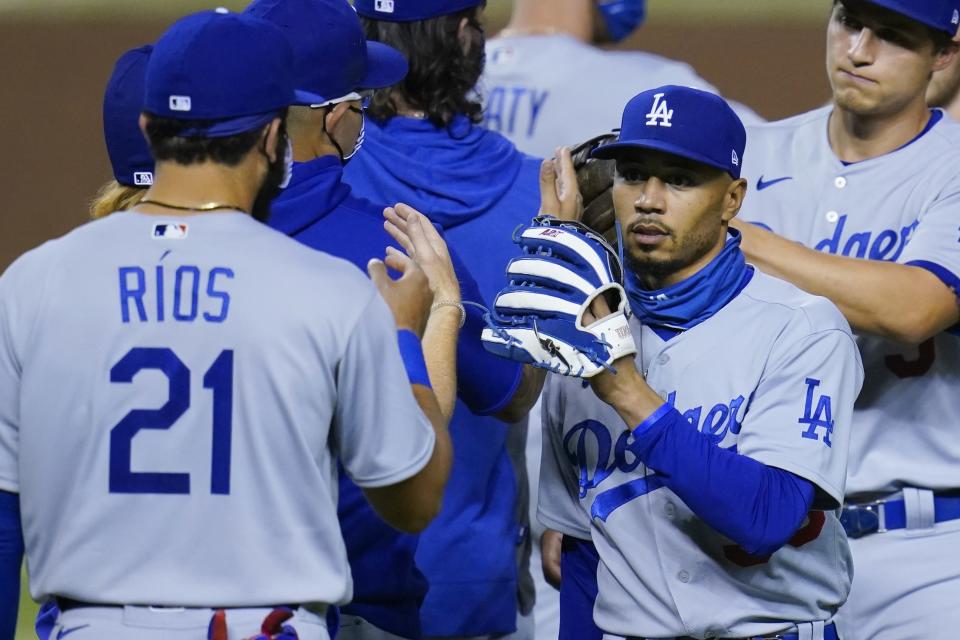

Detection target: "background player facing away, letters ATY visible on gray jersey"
[480, 0, 762, 157]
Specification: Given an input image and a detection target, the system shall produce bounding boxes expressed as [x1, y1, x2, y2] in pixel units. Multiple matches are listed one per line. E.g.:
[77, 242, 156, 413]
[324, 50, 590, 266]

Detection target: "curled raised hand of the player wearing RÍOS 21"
[367, 249, 433, 338]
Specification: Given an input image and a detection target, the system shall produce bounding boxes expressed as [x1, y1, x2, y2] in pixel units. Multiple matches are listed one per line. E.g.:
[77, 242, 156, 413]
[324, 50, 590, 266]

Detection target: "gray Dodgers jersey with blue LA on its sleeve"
[539, 272, 863, 638]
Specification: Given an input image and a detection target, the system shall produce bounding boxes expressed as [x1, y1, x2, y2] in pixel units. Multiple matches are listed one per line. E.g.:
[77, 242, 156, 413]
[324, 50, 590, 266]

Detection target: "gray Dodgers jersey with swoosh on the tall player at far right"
[740, 107, 960, 495]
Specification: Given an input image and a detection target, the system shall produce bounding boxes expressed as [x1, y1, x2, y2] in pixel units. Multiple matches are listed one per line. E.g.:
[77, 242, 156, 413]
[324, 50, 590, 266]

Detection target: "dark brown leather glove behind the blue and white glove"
[570, 133, 617, 247]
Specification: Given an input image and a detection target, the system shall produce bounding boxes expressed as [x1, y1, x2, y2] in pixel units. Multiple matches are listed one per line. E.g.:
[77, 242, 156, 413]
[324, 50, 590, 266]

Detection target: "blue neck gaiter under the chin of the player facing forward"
[626, 229, 753, 331]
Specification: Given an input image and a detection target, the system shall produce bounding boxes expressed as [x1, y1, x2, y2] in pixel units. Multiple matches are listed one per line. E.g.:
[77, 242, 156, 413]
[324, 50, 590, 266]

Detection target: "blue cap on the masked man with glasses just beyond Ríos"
[244, 0, 407, 104]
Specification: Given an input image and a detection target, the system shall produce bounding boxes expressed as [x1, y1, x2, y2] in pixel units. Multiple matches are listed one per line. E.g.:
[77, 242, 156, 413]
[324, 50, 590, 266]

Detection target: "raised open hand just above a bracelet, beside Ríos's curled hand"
[383, 204, 460, 302]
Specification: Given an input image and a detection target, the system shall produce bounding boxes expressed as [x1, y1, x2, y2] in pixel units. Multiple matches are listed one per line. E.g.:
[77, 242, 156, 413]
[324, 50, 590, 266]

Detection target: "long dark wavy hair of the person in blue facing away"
[361, 5, 485, 127]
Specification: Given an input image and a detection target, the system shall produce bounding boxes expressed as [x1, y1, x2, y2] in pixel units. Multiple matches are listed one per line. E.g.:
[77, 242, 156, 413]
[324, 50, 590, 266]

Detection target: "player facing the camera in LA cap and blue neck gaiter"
[512, 86, 862, 639]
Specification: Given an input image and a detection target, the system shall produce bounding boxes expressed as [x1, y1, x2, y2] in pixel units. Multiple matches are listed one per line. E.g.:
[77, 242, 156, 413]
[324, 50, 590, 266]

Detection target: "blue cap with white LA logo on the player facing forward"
[591, 85, 747, 178]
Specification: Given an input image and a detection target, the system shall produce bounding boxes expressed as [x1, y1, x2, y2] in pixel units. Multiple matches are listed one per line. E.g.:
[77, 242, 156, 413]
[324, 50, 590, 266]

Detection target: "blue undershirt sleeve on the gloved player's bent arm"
[633, 404, 816, 556]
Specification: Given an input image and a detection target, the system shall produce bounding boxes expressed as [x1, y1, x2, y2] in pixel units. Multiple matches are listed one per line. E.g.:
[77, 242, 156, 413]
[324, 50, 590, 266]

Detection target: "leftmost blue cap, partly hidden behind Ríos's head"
[103, 45, 153, 187]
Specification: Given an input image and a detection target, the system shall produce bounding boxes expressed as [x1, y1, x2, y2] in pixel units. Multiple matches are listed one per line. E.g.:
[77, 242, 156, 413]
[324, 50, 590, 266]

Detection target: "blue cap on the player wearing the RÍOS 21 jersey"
[143, 9, 322, 138]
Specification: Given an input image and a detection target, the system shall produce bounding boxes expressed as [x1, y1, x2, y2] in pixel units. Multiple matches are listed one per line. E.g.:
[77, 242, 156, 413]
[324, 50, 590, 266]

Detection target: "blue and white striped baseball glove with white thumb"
[481, 216, 636, 378]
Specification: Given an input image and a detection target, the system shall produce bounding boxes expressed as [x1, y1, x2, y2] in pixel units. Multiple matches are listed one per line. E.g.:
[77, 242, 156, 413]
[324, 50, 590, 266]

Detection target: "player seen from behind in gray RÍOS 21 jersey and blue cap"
[0, 10, 450, 640]
